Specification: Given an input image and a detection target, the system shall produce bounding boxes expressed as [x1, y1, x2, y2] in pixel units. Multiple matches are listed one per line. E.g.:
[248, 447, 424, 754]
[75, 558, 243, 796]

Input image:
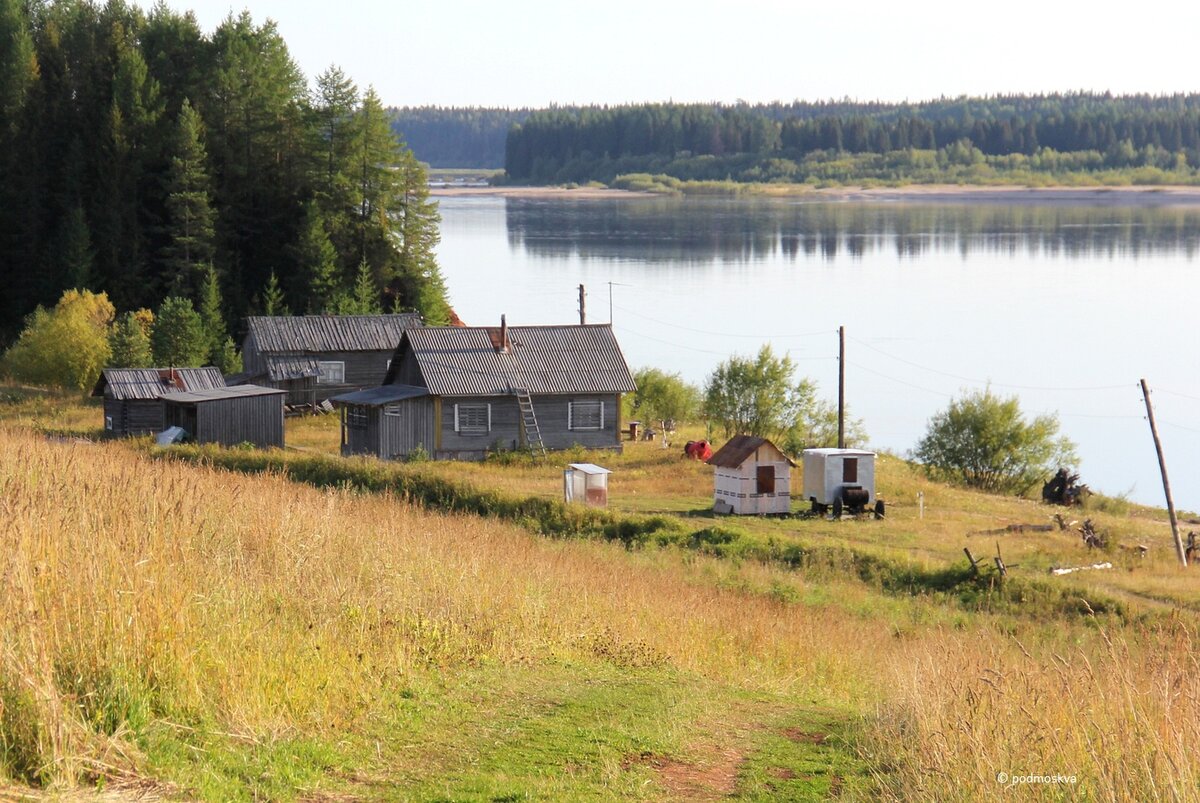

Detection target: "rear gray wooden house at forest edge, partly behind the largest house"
[234, 312, 421, 405]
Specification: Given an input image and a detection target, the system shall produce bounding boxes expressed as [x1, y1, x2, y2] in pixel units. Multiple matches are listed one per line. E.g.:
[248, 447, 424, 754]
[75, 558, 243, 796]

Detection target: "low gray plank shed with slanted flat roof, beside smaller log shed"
[162, 385, 287, 449]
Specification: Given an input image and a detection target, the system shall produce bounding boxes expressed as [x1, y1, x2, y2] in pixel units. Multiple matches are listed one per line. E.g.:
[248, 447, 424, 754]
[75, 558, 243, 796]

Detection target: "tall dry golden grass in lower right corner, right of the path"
[868, 619, 1200, 801]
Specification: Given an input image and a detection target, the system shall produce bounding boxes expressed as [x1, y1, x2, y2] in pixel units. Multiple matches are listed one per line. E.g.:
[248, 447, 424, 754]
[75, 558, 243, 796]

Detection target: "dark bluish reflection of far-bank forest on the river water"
[505, 198, 1200, 263]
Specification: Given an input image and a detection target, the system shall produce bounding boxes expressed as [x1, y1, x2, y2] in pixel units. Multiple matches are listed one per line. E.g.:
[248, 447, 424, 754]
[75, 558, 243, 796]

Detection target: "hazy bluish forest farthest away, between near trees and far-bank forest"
[388, 106, 530, 170]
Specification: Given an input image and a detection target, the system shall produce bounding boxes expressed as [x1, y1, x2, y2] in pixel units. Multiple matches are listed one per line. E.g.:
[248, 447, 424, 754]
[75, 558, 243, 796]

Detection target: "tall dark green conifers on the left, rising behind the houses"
[0, 0, 448, 341]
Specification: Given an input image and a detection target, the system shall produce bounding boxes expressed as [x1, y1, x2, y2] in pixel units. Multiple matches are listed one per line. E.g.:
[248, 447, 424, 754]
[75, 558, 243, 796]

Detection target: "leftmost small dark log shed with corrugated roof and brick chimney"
[91, 367, 226, 437]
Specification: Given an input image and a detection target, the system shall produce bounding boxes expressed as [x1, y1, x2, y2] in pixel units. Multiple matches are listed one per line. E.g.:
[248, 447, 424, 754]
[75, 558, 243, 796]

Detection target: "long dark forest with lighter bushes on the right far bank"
[504, 92, 1200, 184]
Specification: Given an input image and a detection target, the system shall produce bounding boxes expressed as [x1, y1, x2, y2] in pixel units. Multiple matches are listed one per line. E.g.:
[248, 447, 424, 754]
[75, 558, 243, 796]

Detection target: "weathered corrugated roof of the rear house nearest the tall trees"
[246, 312, 421, 354]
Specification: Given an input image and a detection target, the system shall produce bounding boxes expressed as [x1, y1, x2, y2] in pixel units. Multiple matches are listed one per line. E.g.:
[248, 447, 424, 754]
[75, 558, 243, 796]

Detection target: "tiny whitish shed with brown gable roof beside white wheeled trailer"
[708, 435, 796, 516]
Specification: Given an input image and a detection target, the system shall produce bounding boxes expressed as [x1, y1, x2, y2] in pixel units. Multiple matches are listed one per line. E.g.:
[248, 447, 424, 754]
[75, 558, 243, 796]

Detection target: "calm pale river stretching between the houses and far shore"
[438, 197, 1200, 510]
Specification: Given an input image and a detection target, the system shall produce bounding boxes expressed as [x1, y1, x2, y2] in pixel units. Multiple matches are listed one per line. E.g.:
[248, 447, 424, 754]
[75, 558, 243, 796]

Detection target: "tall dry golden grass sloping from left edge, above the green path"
[0, 429, 892, 786]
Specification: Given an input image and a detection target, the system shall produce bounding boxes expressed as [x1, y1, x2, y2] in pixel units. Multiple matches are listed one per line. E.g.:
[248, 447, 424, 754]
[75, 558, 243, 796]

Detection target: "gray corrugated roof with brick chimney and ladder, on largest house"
[384, 324, 637, 396]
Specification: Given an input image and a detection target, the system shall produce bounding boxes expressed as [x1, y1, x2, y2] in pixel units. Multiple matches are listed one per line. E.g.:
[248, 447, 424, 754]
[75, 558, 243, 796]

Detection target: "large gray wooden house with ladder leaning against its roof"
[331, 318, 635, 460]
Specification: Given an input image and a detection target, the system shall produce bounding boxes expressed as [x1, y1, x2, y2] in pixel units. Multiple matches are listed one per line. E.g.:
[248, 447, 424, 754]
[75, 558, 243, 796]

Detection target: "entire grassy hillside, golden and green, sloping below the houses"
[0, 389, 1200, 801]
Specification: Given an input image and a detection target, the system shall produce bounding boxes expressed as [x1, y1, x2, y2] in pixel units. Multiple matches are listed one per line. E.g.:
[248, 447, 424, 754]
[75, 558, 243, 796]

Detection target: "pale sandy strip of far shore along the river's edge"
[430, 184, 1200, 206]
